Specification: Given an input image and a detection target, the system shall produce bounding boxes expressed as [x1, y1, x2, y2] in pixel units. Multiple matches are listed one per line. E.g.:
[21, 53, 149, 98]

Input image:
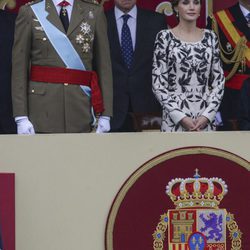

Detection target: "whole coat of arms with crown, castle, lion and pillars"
[153, 169, 242, 250]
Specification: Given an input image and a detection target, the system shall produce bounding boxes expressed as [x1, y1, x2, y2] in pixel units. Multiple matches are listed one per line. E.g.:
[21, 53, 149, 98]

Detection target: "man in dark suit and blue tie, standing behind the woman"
[106, 0, 167, 132]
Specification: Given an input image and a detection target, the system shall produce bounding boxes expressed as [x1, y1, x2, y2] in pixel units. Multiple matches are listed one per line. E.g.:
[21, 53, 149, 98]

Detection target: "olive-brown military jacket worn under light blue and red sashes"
[12, 0, 112, 133]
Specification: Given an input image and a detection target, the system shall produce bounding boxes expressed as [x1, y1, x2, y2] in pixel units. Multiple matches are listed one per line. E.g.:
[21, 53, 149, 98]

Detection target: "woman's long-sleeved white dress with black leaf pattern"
[152, 29, 225, 131]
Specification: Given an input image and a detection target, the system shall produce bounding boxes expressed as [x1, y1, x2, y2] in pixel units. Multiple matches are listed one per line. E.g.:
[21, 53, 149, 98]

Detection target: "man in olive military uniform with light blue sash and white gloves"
[12, 0, 112, 134]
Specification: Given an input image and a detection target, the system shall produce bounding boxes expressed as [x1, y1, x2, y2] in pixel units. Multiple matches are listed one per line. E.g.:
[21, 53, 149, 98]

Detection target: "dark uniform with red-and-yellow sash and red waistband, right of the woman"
[209, 3, 250, 130]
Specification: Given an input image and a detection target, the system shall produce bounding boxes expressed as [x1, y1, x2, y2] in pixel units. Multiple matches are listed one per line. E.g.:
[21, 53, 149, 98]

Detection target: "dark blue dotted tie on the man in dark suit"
[121, 14, 134, 69]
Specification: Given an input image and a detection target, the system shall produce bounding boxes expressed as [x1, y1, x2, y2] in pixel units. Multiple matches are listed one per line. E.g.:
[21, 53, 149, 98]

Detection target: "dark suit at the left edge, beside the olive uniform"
[0, 10, 16, 134]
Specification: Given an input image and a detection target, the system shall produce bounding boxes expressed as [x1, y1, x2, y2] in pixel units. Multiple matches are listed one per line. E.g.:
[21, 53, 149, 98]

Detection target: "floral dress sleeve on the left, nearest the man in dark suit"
[152, 30, 186, 124]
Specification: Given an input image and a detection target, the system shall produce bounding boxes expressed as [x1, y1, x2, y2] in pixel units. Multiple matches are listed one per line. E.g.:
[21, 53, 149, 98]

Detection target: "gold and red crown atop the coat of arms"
[166, 169, 228, 209]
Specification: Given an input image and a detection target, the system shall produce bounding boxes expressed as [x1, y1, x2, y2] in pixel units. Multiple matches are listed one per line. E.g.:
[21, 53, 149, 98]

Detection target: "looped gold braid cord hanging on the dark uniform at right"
[210, 15, 248, 81]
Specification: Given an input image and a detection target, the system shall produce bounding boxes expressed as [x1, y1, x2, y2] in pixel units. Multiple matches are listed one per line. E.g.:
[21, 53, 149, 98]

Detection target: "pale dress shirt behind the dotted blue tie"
[115, 5, 137, 50]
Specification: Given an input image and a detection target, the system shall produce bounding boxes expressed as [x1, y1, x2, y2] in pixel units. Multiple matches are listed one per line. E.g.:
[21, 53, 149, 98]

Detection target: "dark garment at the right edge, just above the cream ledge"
[239, 77, 250, 130]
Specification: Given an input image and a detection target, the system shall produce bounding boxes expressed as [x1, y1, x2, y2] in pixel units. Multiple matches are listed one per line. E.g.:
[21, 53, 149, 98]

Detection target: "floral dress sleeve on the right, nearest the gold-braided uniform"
[202, 32, 225, 122]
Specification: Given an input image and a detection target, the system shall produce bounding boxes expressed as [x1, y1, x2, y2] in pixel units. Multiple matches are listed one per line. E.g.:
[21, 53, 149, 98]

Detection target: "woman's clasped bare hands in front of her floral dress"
[180, 115, 209, 131]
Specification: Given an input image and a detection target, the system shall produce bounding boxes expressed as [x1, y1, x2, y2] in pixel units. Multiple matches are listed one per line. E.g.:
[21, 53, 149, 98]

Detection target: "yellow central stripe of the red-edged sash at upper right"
[217, 10, 250, 61]
